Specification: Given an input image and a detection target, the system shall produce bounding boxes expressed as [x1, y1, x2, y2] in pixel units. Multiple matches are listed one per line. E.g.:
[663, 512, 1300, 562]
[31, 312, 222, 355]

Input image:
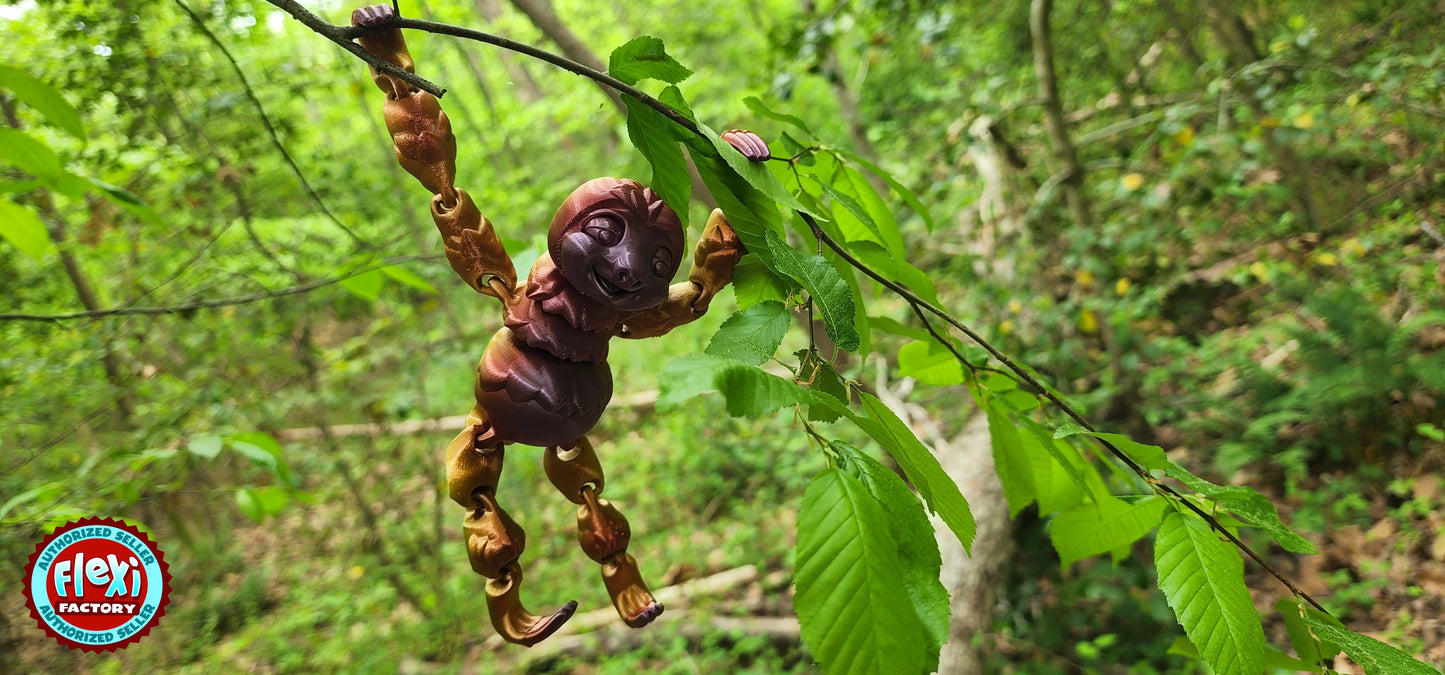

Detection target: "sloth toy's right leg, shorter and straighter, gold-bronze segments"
[542, 437, 662, 629]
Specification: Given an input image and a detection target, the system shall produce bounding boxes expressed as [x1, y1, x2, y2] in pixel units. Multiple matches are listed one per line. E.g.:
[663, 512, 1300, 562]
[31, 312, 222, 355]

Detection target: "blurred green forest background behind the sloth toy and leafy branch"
[0, 0, 1445, 674]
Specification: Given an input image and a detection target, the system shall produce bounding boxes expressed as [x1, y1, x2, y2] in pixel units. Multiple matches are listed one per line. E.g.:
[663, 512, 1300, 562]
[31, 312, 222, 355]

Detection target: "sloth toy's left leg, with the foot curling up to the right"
[447, 406, 577, 646]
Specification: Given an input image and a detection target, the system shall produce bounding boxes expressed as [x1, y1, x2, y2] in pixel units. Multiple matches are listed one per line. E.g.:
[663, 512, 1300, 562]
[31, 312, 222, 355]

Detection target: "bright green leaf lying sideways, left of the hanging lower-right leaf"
[1049, 496, 1165, 569]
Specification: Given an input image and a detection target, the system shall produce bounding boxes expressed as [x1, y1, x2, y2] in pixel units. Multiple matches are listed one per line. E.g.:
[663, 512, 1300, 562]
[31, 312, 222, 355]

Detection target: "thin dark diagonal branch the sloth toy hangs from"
[266, 0, 1328, 614]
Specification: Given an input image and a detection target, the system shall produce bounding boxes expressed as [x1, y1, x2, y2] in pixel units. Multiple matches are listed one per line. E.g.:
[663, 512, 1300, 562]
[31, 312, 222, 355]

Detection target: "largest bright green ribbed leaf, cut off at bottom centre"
[793, 468, 926, 675]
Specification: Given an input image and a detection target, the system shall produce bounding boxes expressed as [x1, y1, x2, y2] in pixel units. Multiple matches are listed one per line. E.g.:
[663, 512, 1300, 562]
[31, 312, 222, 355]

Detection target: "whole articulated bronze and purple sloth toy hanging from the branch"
[351, 4, 767, 646]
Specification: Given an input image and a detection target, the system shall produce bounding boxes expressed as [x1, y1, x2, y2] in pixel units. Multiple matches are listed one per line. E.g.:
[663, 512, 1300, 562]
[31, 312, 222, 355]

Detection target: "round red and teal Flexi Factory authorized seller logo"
[25, 517, 171, 652]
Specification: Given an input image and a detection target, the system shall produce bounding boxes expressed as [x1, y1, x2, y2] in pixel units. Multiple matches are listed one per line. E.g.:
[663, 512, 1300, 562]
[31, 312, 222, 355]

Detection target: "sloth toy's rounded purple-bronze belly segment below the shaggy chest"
[475, 328, 613, 447]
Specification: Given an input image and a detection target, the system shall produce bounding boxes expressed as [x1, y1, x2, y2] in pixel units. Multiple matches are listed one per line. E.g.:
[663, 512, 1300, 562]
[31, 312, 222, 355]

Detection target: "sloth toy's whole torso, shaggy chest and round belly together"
[475, 253, 620, 447]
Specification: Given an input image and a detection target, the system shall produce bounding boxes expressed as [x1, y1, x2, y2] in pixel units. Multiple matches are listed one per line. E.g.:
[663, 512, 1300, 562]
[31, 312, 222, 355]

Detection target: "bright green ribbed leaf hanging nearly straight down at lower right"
[1155, 510, 1265, 675]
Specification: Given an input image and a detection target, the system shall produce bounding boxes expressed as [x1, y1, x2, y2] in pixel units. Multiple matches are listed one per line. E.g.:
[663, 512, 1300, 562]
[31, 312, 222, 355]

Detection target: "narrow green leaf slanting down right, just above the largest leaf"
[842, 390, 977, 549]
